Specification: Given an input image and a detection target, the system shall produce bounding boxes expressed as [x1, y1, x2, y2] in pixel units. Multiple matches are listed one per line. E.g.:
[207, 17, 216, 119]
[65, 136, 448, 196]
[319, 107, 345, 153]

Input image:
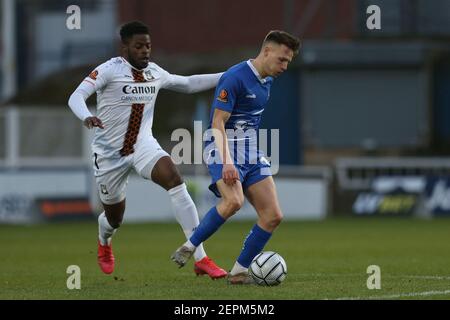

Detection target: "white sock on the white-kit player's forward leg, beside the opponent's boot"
[168, 183, 206, 261]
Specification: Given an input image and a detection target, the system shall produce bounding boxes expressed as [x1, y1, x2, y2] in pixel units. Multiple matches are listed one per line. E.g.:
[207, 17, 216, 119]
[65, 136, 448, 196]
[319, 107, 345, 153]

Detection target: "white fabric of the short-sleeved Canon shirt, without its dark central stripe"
[84, 57, 176, 157]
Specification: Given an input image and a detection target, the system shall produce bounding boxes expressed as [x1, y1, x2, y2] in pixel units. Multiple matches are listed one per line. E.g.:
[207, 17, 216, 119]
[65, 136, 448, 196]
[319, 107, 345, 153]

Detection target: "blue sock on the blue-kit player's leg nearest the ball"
[237, 224, 272, 268]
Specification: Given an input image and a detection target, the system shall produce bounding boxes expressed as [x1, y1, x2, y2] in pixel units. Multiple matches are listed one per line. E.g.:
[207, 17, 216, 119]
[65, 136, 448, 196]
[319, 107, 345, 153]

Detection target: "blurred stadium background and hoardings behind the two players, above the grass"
[0, 0, 450, 223]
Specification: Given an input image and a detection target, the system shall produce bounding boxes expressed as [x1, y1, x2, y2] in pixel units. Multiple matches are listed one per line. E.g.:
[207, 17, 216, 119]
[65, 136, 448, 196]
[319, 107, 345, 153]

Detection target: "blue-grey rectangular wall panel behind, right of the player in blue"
[302, 68, 428, 147]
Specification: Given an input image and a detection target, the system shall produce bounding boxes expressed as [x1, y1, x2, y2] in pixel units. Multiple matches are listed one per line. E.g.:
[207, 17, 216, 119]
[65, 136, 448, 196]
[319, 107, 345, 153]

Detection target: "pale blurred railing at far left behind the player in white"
[0, 106, 91, 168]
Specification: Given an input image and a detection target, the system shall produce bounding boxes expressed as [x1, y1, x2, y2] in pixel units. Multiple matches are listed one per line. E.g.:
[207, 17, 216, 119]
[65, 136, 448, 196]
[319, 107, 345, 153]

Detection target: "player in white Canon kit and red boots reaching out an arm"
[69, 21, 227, 279]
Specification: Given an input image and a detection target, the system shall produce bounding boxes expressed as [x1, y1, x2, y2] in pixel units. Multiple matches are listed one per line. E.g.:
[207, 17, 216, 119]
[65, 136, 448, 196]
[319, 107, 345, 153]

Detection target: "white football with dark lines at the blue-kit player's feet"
[249, 251, 287, 286]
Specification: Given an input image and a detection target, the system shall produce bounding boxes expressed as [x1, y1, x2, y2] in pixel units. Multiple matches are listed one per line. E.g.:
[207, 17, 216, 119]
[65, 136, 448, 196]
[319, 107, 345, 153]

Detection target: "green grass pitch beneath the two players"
[0, 218, 450, 300]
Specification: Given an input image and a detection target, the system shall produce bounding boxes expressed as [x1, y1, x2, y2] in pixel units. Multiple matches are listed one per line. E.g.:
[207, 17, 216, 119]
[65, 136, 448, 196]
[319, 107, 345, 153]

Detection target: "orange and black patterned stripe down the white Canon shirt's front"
[120, 69, 145, 157]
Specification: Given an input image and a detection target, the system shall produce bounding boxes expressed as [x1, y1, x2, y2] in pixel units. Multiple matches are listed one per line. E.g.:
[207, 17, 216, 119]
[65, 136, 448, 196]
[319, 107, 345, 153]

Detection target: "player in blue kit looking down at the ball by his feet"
[171, 30, 300, 284]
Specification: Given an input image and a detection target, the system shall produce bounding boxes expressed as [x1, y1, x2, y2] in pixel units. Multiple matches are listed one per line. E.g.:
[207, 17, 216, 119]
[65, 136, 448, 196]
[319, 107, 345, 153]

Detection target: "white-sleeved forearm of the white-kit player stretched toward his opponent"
[165, 73, 223, 93]
